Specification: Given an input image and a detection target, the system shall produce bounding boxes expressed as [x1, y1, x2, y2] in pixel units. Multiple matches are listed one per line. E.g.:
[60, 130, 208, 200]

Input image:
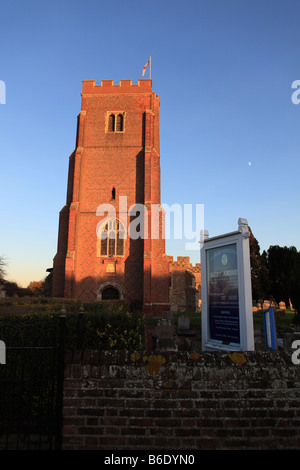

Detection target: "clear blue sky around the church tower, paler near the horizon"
[0, 0, 300, 286]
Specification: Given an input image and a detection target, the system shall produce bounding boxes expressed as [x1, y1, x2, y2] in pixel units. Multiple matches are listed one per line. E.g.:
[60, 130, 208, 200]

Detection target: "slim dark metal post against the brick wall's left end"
[55, 315, 66, 450]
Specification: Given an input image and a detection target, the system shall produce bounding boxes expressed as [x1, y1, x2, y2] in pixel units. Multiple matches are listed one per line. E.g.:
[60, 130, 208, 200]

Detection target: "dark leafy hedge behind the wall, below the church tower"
[0, 301, 146, 350]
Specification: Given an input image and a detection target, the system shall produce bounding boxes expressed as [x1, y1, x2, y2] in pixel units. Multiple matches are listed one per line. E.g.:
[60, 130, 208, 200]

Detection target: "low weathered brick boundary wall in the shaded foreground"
[63, 351, 300, 451]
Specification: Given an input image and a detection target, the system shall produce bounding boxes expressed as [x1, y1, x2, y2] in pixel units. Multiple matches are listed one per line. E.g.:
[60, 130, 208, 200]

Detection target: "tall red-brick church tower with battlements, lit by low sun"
[52, 79, 170, 315]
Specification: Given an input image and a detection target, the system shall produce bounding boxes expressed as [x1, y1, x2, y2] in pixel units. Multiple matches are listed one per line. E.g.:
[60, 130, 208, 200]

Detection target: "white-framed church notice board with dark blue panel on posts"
[201, 219, 254, 351]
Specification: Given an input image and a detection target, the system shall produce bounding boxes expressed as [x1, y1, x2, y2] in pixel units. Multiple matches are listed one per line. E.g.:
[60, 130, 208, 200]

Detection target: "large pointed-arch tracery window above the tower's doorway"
[97, 219, 125, 256]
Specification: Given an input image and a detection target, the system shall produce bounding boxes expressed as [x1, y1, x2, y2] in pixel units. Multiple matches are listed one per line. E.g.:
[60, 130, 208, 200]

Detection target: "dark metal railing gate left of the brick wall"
[0, 315, 66, 450]
